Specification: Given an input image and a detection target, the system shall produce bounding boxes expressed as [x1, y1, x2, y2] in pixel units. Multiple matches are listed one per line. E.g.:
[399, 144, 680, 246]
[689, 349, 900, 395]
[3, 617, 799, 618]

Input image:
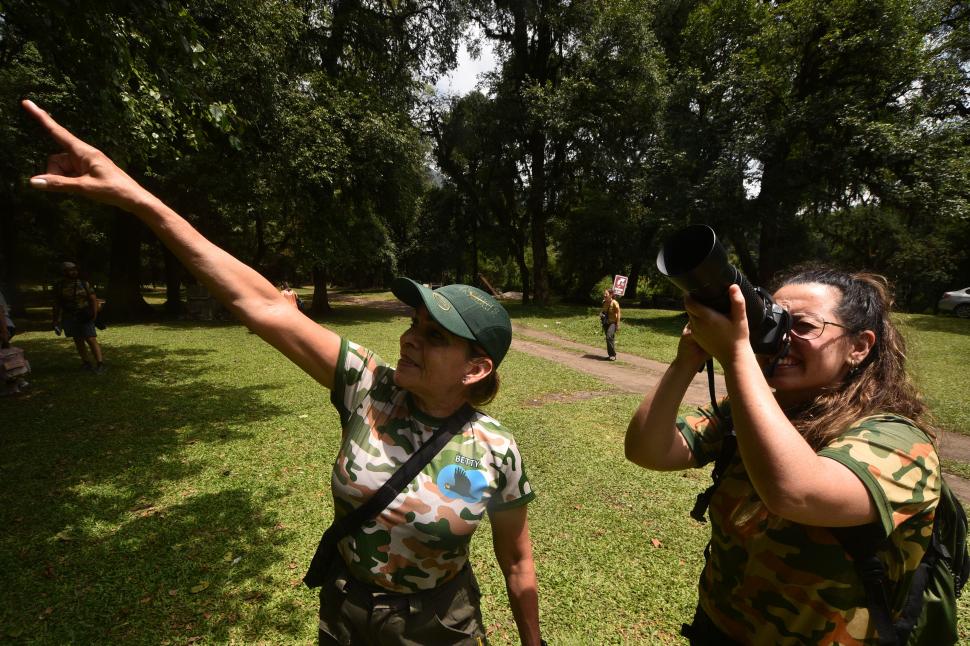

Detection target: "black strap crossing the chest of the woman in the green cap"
[303, 403, 475, 588]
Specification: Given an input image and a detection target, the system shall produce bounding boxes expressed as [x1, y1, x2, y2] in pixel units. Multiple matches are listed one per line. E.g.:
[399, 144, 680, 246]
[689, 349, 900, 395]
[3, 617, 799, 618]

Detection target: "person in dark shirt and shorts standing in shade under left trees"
[53, 262, 104, 373]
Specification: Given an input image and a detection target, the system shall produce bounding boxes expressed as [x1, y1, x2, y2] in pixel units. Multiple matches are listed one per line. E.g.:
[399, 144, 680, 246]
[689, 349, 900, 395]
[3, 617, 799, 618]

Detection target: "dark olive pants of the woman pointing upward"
[319, 563, 485, 646]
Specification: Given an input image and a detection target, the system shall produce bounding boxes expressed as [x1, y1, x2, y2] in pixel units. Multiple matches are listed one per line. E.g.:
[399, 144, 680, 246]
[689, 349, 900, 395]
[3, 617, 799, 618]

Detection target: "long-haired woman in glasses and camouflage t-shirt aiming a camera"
[626, 268, 941, 644]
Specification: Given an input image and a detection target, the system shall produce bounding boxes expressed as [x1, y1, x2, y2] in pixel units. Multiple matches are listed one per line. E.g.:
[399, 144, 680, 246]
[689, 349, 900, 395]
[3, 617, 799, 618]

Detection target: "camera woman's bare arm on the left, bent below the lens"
[624, 327, 707, 471]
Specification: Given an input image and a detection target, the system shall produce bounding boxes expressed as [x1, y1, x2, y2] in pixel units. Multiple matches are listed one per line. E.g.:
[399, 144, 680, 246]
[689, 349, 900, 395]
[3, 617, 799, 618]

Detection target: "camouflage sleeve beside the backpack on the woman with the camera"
[818, 415, 942, 536]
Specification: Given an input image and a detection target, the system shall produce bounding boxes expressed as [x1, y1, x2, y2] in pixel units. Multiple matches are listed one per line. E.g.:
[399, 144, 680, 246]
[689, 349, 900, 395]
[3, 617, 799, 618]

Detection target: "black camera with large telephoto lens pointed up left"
[657, 224, 791, 355]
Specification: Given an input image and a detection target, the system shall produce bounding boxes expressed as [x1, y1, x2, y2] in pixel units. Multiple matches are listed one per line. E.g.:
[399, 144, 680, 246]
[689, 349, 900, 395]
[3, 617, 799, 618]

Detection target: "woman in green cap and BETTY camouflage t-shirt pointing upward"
[23, 101, 540, 646]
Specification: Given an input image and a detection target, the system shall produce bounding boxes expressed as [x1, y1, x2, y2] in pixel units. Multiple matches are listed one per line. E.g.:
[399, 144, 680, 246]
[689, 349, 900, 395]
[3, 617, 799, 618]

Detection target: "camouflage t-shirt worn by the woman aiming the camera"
[677, 405, 941, 644]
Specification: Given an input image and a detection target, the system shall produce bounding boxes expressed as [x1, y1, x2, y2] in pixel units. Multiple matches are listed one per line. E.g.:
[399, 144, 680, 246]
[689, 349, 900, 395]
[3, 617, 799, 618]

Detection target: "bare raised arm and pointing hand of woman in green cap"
[22, 101, 340, 388]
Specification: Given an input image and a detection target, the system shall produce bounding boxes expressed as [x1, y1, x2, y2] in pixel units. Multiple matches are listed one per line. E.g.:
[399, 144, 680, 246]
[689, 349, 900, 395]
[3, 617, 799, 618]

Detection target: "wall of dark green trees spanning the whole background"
[0, 0, 970, 318]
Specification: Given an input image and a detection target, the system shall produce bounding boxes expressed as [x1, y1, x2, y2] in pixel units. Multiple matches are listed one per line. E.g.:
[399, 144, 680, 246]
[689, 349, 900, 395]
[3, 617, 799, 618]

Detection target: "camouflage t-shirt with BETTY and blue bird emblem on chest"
[330, 339, 535, 592]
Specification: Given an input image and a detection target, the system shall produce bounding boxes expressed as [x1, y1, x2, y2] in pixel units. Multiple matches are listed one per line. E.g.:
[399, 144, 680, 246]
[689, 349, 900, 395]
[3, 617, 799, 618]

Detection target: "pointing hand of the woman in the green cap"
[21, 99, 147, 210]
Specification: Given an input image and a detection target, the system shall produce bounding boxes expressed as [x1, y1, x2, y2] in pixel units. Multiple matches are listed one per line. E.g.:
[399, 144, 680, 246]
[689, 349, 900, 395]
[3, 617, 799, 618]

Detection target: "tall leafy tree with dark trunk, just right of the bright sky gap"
[477, 0, 659, 303]
